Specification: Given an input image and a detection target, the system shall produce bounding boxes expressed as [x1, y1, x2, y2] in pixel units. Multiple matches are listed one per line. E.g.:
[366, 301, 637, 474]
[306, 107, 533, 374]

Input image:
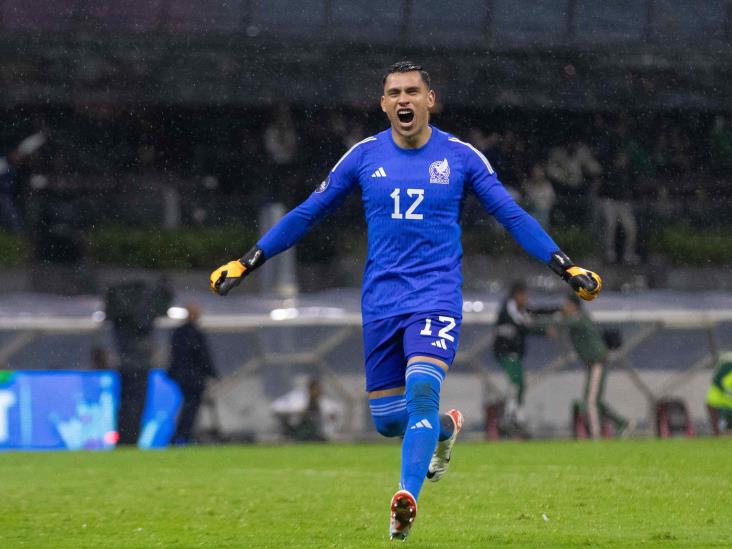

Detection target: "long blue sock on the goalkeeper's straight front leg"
[401, 362, 445, 499]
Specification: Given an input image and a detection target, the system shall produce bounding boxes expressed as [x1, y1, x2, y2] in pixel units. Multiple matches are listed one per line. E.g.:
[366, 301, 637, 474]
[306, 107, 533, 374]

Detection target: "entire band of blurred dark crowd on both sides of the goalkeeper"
[0, 105, 732, 263]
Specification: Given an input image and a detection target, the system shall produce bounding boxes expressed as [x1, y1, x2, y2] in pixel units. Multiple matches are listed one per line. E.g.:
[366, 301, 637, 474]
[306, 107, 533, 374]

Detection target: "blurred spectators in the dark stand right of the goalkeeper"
[468, 113, 732, 263]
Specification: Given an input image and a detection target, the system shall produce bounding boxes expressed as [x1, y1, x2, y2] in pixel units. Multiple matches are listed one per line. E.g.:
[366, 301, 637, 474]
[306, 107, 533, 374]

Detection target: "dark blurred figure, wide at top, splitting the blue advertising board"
[105, 279, 172, 444]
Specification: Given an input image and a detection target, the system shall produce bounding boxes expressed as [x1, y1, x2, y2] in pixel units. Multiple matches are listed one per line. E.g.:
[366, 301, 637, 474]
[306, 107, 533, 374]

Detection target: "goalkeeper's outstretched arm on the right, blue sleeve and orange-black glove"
[466, 149, 602, 301]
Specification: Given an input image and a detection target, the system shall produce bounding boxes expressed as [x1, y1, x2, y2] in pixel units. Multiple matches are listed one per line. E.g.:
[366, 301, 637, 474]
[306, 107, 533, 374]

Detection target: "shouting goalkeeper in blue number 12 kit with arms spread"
[211, 61, 602, 540]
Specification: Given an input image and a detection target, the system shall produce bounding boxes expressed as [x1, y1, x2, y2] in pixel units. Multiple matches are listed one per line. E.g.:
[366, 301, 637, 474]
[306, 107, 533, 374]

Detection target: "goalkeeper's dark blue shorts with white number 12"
[363, 312, 462, 392]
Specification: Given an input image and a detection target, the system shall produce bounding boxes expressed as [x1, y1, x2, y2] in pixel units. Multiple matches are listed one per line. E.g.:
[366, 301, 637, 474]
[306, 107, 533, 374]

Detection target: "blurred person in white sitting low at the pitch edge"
[271, 378, 343, 441]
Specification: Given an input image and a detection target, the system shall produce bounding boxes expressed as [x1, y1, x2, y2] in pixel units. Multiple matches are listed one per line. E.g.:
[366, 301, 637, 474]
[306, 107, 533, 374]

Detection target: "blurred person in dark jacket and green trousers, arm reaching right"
[493, 281, 556, 435]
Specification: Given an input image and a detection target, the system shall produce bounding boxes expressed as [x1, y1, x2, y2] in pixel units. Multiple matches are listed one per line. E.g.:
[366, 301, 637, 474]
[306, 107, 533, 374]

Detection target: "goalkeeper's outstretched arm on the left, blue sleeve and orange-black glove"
[210, 142, 363, 296]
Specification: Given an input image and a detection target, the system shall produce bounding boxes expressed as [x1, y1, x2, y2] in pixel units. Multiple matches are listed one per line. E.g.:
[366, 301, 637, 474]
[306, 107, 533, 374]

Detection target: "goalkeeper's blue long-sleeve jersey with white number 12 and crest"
[257, 126, 559, 322]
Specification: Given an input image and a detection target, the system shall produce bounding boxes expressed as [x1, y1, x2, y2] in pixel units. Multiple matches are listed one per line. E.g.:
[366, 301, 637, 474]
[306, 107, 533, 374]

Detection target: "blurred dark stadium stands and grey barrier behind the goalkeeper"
[0, 0, 732, 444]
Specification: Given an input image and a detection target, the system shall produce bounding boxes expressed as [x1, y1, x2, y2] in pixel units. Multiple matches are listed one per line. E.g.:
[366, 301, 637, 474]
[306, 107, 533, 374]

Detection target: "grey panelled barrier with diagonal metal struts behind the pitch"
[0, 299, 732, 440]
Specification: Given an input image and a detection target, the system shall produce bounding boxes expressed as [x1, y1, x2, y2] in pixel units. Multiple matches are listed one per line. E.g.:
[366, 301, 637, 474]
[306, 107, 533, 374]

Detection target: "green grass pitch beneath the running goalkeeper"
[0, 439, 732, 548]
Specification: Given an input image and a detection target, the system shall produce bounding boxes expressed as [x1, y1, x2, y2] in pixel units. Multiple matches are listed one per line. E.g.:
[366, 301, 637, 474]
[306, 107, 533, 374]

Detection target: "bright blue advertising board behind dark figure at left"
[0, 370, 183, 450]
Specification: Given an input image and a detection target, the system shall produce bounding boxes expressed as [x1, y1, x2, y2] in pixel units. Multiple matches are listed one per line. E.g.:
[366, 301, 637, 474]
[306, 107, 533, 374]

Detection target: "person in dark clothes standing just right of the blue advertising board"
[168, 304, 218, 444]
